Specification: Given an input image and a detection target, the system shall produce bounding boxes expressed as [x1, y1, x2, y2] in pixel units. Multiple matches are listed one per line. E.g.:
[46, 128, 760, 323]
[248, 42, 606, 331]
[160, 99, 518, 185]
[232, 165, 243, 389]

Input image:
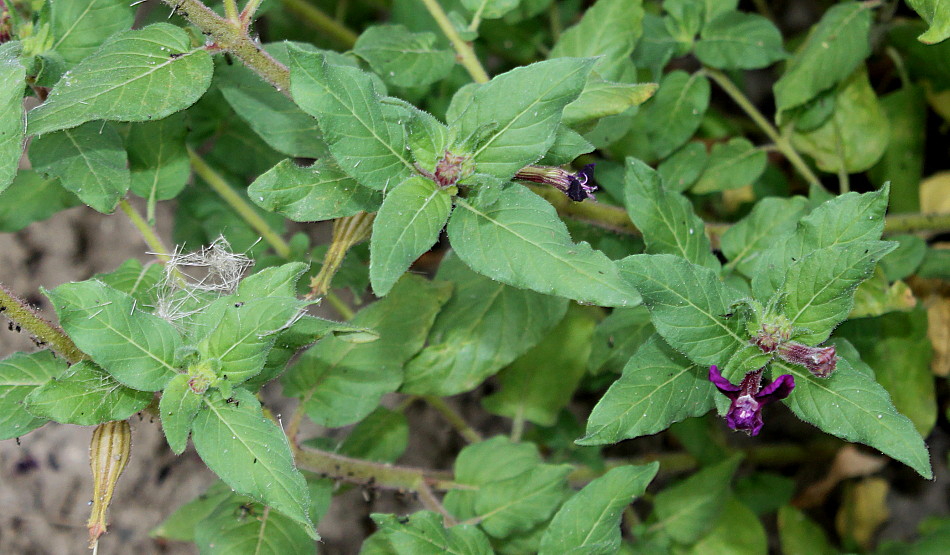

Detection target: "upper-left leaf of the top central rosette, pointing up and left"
[290, 46, 413, 190]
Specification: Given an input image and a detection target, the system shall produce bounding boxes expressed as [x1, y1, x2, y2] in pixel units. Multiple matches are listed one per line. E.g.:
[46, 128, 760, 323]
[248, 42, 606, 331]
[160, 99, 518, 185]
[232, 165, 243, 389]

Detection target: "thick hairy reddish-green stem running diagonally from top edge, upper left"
[162, 0, 290, 91]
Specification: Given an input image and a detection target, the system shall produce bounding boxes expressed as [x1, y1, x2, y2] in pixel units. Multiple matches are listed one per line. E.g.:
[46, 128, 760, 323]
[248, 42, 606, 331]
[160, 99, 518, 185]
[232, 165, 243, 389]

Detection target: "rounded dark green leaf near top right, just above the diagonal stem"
[694, 12, 788, 69]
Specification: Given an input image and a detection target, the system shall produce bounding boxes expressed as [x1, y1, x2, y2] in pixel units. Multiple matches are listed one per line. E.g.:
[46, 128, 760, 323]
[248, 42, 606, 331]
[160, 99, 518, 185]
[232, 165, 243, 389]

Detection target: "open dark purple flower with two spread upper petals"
[709, 365, 795, 436]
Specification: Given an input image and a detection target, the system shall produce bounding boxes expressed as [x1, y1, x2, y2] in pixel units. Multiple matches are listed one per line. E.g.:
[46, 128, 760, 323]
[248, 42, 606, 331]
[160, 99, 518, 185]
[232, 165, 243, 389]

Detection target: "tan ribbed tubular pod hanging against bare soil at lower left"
[86, 420, 132, 549]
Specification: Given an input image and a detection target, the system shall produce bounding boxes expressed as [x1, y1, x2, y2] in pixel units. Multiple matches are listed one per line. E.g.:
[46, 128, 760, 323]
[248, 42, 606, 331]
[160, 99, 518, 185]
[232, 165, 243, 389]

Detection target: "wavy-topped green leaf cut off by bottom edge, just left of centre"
[370, 511, 494, 555]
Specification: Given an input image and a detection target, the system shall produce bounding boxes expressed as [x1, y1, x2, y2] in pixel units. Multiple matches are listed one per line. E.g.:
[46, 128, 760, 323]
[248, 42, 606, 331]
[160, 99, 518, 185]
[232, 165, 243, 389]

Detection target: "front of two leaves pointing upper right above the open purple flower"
[770, 241, 897, 345]
